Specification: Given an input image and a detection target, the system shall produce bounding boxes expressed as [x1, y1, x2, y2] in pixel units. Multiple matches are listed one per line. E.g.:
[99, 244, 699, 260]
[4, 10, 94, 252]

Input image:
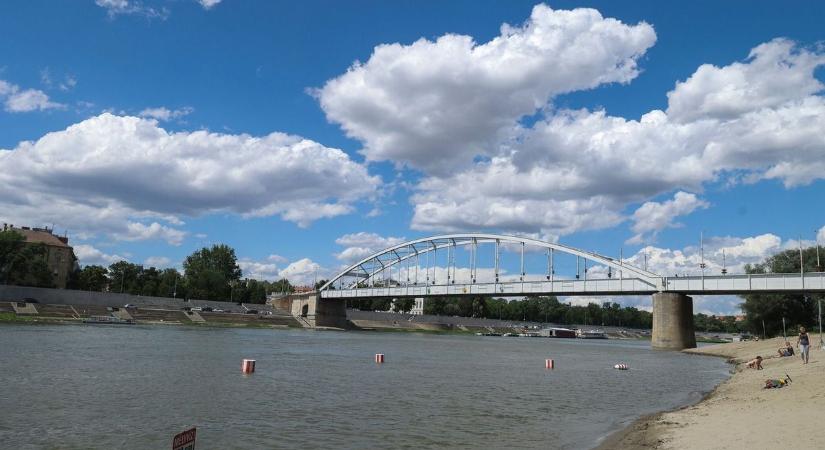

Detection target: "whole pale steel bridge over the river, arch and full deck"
[318, 233, 825, 299]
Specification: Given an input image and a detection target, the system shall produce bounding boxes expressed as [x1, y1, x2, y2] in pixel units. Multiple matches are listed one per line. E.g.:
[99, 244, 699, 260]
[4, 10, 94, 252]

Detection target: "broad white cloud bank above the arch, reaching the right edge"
[402, 40, 825, 237]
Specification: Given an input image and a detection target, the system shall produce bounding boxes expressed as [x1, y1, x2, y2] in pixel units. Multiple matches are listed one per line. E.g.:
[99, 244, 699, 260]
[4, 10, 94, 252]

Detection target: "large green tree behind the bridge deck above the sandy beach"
[742, 247, 823, 336]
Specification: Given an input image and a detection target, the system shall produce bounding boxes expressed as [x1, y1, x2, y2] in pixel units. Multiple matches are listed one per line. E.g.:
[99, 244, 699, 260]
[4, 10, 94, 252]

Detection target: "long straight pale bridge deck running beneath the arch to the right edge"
[320, 272, 825, 299]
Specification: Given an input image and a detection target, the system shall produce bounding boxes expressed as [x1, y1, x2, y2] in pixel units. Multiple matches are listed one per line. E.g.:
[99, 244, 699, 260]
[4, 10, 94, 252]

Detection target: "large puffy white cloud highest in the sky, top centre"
[316, 4, 656, 174]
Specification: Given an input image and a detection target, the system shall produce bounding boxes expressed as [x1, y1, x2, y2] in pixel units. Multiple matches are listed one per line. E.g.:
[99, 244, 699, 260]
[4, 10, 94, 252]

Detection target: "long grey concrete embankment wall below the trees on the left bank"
[0, 285, 277, 312]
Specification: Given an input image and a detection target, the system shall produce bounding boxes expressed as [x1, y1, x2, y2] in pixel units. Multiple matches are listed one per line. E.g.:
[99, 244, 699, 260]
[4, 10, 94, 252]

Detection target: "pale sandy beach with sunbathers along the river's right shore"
[599, 334, 825, 449]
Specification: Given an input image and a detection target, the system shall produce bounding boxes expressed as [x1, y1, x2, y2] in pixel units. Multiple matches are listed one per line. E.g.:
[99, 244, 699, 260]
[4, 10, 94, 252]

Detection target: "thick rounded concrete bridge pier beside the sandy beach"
[651, 292, 696, 350]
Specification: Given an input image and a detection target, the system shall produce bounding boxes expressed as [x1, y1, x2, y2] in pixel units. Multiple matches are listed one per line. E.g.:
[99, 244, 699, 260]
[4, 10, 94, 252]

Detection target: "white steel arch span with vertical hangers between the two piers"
[319, 233, 663, 298]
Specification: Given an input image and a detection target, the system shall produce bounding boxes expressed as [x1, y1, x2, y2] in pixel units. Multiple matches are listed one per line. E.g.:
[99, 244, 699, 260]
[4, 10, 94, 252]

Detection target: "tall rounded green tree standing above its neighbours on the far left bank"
[183, 244, 241, 300]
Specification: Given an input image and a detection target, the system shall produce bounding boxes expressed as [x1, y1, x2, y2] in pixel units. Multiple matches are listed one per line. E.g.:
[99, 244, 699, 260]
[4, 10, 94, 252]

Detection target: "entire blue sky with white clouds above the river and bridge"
[0, 0, 825, 313]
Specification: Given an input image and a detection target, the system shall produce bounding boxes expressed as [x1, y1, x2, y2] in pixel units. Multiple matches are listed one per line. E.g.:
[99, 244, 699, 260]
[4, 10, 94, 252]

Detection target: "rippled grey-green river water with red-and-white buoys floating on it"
[0, 325, 728, 450]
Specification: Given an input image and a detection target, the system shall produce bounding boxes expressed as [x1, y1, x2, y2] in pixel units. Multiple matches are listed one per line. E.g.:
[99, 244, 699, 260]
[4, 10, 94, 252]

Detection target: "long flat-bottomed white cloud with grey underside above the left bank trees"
[0, 113, 380, 245]
